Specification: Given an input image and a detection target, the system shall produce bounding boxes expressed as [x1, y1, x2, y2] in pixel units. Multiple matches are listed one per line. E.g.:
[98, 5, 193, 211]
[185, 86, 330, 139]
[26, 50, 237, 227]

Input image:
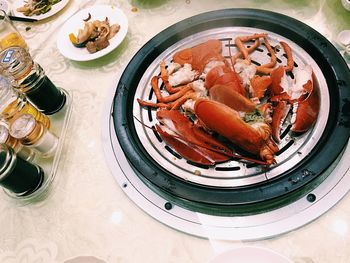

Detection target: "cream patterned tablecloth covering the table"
[0, 0, 350, 263]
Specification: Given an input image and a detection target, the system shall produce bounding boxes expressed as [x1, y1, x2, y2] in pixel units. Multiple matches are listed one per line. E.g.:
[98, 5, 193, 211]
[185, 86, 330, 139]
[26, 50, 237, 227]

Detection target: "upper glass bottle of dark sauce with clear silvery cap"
[0, 47, 66, 115]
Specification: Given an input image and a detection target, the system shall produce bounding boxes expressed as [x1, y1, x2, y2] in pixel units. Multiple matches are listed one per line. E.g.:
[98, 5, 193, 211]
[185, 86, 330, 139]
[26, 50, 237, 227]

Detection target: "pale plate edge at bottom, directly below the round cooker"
[208, 247, 293, 263]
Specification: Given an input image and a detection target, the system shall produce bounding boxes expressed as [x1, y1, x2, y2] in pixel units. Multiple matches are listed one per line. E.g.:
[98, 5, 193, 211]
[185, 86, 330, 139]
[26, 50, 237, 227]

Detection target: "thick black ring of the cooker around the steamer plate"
[113, 9, 350, 214]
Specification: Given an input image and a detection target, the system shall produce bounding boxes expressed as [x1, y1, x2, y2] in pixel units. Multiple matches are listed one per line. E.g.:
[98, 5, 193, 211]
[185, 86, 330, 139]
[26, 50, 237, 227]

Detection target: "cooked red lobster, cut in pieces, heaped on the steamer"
[138, 34, 319, 165]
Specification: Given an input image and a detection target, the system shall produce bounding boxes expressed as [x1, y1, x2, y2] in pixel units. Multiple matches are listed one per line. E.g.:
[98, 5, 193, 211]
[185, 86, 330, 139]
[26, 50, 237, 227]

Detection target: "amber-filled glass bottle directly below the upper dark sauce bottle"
[0, 75, 50, 128]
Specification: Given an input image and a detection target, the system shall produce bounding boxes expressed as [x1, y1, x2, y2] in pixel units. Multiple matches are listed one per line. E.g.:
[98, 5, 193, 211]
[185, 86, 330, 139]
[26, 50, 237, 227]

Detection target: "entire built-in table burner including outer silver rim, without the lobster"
[103, 9, 350, 240]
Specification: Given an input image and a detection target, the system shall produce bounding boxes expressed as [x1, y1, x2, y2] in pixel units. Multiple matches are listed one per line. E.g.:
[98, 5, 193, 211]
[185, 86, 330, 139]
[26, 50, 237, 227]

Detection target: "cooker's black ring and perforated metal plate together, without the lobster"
[112, 9, 350, 216]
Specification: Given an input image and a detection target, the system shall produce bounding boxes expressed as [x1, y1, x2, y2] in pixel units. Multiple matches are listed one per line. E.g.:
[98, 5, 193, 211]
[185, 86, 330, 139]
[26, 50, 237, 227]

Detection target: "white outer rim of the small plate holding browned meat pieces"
[56, 4, 129, 62]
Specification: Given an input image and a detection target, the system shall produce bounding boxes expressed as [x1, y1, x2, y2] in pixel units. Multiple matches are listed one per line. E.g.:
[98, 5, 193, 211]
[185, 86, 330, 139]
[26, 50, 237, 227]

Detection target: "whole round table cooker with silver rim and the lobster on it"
[104, 9, 350, 239]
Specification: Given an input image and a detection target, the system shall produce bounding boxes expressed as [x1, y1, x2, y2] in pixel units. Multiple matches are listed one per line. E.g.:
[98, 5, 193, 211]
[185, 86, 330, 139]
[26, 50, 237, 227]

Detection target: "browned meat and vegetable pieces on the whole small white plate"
[69, 14, 120, 54]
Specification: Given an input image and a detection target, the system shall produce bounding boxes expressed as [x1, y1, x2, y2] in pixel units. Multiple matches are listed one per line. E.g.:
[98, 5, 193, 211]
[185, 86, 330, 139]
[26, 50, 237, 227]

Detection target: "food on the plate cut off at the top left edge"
[16, 0, 61, 16]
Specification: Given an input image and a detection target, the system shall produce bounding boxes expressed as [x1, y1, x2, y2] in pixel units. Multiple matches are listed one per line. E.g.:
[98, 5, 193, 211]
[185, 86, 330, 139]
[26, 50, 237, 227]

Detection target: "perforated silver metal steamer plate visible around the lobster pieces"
[133, 27, 329, 187]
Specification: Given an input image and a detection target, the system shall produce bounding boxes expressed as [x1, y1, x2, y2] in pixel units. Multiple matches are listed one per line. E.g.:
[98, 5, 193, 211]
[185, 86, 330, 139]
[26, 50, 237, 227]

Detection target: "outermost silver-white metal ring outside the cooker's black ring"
[102, 89, 350, 240]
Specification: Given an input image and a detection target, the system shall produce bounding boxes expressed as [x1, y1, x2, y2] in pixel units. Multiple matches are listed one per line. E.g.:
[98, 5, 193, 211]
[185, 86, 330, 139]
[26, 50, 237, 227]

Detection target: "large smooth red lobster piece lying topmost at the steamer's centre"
[195, 99, 278, 164]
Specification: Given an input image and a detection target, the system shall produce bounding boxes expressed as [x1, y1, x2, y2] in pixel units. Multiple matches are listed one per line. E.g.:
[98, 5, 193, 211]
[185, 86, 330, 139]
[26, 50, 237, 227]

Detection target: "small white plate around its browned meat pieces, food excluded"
[57, 5, 128, 61]
